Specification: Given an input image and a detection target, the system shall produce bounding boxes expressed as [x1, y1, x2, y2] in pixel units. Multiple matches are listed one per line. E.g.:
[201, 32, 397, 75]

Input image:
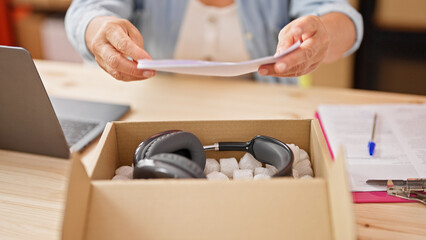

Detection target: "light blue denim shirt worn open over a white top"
[65, 0, 363, 84]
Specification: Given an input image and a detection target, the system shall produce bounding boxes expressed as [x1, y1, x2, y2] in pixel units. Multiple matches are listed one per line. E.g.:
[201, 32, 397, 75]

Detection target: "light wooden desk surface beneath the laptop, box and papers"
[0, 61, 426, 239]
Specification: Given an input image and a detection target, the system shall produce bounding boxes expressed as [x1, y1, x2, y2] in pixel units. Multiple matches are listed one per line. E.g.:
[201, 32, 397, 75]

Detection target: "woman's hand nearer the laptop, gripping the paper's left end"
[86, 16, 156, 81]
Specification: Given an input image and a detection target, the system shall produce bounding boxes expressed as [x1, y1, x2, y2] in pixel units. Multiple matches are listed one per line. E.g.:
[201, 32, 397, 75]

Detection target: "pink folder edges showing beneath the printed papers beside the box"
[315, 112, 415, 203]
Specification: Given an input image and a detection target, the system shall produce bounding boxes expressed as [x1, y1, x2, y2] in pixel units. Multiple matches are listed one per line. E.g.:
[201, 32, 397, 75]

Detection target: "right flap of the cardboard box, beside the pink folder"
[311, 119, 356, 239]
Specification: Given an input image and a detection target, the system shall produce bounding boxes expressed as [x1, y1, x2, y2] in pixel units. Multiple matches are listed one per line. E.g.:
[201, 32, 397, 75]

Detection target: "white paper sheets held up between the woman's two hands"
[137, 41, 300, 77]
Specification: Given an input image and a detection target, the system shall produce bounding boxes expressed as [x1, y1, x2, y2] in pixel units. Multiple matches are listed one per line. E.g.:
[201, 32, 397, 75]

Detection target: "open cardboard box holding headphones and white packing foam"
[62, 120, 356, 240]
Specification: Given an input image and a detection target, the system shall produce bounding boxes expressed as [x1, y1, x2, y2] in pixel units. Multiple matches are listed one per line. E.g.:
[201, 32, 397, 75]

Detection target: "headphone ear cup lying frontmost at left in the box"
[133, 153, 205, 178]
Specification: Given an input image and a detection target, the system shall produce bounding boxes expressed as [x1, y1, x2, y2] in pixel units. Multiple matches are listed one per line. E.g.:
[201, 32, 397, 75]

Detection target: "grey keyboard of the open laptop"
[59, 119, 99, 147]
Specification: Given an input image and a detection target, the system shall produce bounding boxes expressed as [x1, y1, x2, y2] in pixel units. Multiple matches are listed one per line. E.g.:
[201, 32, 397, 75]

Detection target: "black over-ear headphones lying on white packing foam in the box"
[133, 130, 293, 178]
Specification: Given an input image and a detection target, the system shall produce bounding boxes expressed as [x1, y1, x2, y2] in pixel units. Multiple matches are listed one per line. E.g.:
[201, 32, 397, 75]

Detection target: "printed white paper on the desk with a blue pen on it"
[318, 104, 426, 191]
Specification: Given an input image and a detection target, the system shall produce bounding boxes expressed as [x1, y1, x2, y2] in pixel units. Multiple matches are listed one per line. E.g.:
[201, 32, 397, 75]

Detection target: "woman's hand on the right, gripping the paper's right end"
[258, 15, 330, 77]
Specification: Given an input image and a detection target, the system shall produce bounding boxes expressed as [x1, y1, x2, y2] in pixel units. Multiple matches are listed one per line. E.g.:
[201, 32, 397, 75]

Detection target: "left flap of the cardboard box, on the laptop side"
[62, 153, 90, 240]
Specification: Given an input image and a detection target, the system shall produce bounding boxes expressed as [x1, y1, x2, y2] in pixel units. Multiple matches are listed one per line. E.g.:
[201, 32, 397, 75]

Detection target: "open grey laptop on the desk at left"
[0, 46, 130, 158]
